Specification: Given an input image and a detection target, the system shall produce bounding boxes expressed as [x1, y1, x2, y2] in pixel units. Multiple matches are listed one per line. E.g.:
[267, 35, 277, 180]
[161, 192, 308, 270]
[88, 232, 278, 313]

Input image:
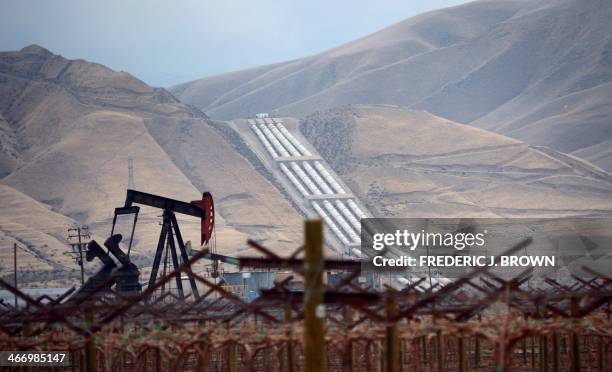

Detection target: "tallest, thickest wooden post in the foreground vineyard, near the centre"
[304, 220, 325, 372]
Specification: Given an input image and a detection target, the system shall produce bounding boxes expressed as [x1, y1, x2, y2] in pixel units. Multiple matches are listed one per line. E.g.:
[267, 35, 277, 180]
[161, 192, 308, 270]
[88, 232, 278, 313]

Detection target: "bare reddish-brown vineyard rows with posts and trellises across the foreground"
[0, 221, 612, 371]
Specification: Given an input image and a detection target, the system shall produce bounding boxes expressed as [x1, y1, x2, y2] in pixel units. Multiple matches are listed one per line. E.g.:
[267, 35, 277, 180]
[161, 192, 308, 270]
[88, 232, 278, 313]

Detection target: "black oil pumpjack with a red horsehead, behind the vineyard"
[68, 189, 215, 302]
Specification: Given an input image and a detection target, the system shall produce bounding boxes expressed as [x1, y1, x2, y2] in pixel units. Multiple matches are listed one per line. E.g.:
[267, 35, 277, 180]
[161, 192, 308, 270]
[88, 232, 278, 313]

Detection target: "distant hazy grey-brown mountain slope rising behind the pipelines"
[171, 0, 612, 169]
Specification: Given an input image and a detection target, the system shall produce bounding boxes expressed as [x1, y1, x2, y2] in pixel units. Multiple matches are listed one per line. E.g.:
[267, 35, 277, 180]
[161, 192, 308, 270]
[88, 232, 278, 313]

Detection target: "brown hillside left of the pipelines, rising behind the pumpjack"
[0, 46, 301, 284]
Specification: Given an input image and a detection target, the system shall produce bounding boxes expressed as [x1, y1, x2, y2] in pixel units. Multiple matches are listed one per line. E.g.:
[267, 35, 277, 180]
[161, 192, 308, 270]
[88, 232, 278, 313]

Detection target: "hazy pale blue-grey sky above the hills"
[0, 0, 466, 86]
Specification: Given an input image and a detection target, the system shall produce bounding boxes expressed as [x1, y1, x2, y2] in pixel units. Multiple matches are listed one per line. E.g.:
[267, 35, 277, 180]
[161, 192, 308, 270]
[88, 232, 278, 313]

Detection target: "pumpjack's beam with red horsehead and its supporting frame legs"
[113, 190, 214, 298]
